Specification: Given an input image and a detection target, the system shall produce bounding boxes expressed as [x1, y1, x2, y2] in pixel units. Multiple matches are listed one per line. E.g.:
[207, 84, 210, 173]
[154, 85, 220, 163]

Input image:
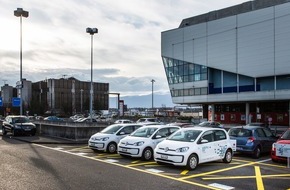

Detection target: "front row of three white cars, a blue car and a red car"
[88, 122, 290, 170]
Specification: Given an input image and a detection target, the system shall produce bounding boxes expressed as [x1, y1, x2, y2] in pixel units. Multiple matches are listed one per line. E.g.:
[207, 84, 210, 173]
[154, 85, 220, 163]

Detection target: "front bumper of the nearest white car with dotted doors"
[154, 151, 187, 166]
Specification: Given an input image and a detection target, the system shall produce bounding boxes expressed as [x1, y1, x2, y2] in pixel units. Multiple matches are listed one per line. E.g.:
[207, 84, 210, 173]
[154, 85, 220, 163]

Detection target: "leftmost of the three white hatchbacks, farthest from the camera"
[88, 123, 142, 153]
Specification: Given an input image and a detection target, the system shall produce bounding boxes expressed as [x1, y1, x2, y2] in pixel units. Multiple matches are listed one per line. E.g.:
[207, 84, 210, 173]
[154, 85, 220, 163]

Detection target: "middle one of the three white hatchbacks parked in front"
[118, 125, 180, 160]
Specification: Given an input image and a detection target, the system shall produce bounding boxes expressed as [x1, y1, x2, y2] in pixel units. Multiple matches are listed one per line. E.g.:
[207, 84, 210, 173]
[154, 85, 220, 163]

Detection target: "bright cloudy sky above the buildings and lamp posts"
[0, 0, 246, 107]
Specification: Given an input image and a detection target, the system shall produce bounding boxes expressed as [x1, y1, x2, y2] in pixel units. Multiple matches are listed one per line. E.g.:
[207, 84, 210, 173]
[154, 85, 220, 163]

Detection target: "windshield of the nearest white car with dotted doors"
[168, 130, 201, 142]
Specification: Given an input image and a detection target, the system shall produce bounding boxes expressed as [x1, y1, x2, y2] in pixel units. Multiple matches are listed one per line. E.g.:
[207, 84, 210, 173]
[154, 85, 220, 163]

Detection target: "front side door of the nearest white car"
[197, 130, 217, 163]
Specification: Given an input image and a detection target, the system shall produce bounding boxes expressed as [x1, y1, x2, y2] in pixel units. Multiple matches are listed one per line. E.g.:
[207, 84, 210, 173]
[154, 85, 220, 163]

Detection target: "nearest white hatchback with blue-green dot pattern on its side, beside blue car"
[154, 127, 236, 170]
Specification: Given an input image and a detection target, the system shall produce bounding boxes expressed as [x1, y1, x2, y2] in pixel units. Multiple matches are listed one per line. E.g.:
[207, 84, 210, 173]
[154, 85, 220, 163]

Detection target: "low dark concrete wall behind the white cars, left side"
[35, 122, 108, 141]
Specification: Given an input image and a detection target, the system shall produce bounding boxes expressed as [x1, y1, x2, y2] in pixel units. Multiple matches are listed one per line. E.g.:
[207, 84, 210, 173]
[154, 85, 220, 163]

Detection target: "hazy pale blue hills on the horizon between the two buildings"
[109, 94, 175, 108]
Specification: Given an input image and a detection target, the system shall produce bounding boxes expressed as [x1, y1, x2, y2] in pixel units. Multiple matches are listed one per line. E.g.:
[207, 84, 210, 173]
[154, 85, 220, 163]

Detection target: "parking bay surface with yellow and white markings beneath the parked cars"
[4, 136, 290, 190]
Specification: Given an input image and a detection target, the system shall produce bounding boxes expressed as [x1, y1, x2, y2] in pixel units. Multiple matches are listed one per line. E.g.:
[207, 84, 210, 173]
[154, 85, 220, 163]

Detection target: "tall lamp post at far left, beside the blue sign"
[14, 8, 29, 115]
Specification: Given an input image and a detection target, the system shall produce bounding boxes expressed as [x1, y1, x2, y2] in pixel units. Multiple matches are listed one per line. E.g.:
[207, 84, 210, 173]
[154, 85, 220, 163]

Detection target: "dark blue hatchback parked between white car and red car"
[228, 126, 277, 158]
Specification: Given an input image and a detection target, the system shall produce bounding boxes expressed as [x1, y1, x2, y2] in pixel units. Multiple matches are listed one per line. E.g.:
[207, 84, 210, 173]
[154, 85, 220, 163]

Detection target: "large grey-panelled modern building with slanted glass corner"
[161, 0, 290, 126]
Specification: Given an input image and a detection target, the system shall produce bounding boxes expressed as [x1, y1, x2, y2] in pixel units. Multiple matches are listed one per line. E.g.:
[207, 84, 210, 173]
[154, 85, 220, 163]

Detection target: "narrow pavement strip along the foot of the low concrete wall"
[0, 130, 89, 144]
